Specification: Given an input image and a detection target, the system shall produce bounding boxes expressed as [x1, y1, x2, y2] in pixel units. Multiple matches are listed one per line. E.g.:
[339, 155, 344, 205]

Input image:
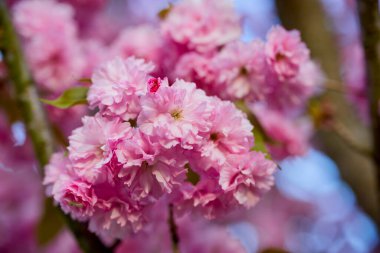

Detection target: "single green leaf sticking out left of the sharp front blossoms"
[40, 86, 88, 109]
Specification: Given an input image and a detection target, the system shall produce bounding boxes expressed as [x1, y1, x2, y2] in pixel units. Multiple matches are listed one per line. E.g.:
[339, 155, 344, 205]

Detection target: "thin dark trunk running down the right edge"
[356, 0, 380, 212]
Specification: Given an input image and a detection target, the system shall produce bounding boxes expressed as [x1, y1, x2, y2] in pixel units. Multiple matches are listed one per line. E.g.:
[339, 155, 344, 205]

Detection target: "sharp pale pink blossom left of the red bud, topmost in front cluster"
[88, 57, 154, 120]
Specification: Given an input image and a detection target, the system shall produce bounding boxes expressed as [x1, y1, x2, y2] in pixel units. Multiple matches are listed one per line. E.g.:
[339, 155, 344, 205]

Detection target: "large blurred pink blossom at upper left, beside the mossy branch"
[14, 0, 85, 93]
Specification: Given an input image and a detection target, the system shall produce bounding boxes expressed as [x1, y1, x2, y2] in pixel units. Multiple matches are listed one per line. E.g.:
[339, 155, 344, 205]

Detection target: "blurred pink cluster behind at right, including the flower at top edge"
[117, 0, 324, 160]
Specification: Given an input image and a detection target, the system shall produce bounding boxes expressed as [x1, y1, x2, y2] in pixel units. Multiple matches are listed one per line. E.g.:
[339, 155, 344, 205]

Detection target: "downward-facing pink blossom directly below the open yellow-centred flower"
[115, 130, 186, 200]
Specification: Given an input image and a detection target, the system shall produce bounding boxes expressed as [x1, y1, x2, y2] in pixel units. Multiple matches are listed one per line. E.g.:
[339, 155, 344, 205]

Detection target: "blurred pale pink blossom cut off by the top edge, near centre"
[162, 0, 241, 52]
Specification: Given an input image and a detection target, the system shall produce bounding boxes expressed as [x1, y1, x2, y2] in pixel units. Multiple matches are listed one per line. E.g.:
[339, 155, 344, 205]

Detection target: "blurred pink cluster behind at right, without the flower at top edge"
[164, 14, 324, 159]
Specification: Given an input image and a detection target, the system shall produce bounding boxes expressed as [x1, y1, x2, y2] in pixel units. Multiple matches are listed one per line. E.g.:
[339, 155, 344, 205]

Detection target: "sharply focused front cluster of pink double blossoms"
[45, 57, 276, 240]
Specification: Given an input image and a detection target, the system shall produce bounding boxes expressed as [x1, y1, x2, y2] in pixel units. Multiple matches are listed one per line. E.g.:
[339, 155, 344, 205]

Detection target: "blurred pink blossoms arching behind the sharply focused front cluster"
[14, 0, 323, 160]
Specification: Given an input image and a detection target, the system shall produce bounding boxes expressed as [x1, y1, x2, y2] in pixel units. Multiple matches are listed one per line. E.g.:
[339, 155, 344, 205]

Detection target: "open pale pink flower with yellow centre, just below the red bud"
[137, 80, 211, 149]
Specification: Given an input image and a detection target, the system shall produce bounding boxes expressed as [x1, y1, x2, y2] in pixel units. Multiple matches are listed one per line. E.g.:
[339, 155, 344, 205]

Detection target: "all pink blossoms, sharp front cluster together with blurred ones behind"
[13, 0, 323, 248]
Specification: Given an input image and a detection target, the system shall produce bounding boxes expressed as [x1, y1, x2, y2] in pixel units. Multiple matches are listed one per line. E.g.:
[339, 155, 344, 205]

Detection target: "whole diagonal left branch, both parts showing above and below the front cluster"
[0, 0, 112, 253]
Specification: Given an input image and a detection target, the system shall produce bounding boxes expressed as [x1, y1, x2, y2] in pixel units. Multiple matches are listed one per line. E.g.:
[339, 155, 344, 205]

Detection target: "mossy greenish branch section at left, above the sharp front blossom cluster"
[0, 1, 54, 170]
